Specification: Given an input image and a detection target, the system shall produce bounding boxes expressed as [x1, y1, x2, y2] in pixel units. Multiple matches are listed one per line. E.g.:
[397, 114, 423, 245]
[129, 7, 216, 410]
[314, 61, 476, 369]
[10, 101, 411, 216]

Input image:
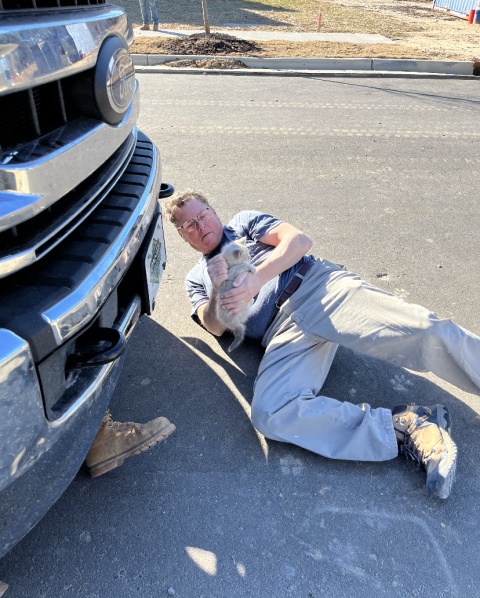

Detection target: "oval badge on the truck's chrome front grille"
[94, 37, 135, 125]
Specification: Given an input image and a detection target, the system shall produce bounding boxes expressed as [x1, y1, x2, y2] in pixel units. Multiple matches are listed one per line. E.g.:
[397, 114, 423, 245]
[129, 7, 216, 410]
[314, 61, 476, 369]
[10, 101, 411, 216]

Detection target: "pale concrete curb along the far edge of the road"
[132, 54, 474, 78]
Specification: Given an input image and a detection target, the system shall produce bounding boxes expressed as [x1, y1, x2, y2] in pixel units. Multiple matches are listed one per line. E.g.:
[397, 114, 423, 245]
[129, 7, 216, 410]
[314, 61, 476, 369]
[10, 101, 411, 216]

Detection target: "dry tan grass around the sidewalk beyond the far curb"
[117, 0, 480, 60]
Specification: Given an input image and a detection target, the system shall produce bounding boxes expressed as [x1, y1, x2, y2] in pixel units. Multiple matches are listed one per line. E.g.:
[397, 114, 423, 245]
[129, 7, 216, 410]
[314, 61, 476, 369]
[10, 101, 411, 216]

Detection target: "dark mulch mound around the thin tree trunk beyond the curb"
[162, 33, 261, 56]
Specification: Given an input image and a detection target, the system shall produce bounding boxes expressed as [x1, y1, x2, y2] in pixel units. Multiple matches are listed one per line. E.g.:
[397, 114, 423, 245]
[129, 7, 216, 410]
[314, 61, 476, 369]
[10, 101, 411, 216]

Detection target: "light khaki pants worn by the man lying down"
[252, 260, 480, 461]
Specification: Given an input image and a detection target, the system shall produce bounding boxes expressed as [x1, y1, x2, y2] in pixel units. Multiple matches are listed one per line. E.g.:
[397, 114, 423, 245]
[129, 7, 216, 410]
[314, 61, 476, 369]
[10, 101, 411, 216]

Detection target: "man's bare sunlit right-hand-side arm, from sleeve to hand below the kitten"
[220, 222, 313, 314]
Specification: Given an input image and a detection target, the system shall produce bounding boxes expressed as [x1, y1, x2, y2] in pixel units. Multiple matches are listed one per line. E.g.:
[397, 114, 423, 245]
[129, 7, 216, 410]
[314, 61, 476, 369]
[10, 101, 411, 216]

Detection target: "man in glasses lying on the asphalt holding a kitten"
[165, 191, 480, 498]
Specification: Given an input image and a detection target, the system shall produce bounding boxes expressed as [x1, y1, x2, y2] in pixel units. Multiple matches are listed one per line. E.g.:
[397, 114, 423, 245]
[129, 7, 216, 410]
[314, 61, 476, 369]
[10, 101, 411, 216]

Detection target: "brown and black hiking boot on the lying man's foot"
[392, 405, 457, 499]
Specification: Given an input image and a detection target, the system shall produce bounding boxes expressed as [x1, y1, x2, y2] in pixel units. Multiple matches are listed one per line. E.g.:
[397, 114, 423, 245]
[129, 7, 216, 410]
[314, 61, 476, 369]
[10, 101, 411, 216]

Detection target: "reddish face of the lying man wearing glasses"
[175, 199, 223, 255]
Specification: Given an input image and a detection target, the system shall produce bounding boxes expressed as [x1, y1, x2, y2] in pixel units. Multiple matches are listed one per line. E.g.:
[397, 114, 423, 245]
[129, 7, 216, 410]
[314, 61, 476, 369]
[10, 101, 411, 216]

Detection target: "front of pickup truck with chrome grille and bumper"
[0, 0, 173, 557]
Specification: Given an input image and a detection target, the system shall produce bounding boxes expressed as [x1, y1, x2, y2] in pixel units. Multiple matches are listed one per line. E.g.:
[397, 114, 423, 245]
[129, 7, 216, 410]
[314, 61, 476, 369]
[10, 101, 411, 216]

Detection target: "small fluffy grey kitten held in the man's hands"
[217, 238, 256, 352]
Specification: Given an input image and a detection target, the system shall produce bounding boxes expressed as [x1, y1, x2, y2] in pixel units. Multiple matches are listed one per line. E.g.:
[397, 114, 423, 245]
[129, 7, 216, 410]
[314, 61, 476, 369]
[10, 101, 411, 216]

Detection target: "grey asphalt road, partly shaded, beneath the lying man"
[0, 75, 480, 598]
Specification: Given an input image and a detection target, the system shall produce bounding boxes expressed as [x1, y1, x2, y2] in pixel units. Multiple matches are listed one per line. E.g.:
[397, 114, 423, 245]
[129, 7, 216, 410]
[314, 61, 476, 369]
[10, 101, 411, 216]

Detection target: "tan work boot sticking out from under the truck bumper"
[85, 411, 175, 478]
